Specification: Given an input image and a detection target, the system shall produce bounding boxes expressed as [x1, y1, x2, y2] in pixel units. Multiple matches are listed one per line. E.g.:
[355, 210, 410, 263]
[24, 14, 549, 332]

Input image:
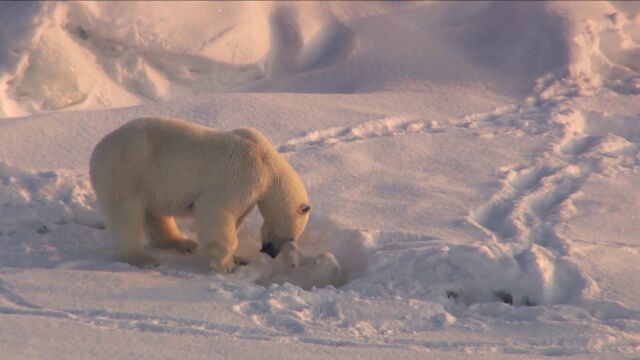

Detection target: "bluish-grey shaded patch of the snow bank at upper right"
[450, 2, 571, 85]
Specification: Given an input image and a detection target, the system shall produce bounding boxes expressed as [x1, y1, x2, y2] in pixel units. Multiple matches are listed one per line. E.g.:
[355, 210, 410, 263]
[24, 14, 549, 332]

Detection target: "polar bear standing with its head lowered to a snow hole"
[90, 117, 311, 273]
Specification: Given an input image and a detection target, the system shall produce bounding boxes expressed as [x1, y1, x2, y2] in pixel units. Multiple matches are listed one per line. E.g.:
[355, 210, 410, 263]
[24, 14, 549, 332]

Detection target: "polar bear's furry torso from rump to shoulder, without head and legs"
[90, 118, 280, 212]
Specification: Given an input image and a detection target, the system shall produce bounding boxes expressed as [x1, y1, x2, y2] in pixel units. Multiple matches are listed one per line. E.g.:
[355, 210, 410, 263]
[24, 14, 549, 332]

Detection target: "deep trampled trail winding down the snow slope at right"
[468, 104, 603, 304]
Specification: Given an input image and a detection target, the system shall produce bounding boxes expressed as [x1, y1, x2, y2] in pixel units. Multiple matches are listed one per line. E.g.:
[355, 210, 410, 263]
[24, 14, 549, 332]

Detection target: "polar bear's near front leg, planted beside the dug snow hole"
[195, 206, 238, 274]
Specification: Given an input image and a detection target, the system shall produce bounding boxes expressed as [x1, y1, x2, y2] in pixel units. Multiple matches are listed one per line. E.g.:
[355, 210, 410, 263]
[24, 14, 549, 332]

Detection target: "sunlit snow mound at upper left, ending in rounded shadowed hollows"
[0, 2, 354, 116]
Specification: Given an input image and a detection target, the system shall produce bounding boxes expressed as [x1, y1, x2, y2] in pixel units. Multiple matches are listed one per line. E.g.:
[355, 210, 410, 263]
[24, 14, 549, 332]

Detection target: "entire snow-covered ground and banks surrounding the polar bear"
[0, 2, 640, 359]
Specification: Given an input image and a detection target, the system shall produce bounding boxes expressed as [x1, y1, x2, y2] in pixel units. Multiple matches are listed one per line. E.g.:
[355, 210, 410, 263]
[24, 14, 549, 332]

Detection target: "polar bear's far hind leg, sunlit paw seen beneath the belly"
[145, 213, 198, 254]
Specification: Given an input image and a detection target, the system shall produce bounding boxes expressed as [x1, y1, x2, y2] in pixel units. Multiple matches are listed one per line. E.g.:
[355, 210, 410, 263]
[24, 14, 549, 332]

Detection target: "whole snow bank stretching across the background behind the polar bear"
[0, 2, 640, 116]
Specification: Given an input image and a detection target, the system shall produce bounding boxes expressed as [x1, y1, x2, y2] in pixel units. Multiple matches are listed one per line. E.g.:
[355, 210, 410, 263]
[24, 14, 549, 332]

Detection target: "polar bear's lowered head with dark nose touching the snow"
[258, 164, 311, 258]
